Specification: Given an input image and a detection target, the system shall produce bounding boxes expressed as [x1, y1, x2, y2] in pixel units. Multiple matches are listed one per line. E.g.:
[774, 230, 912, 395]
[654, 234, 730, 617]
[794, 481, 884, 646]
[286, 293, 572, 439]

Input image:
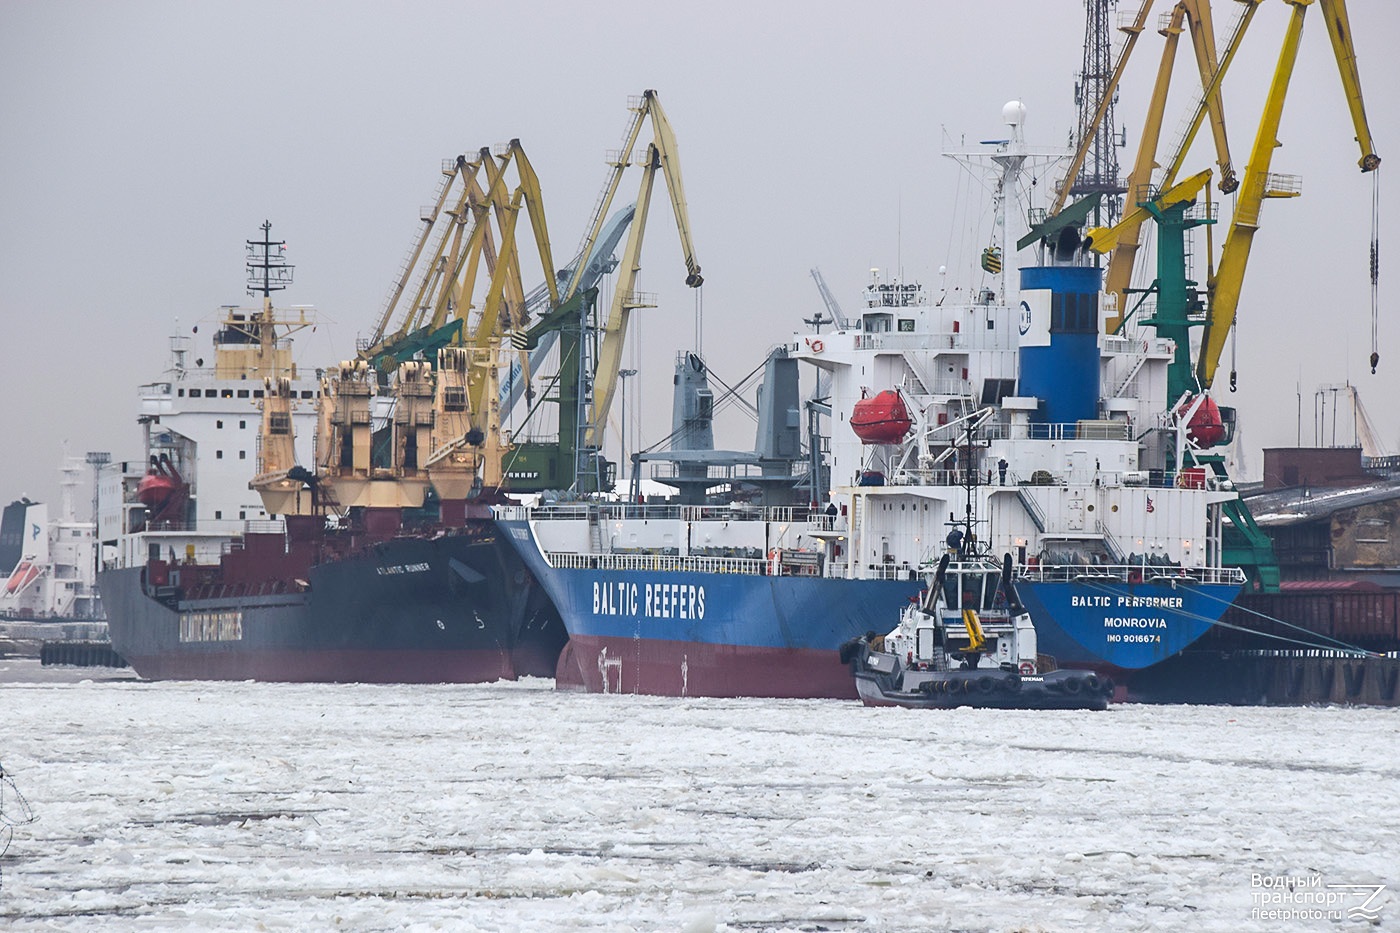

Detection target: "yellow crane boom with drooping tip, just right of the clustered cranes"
[574, 90, 704, 459]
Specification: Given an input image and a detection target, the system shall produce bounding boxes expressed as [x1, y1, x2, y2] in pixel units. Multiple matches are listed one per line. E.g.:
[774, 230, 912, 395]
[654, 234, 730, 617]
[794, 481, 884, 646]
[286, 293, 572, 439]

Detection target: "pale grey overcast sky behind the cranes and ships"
[0, 0, 1400, 502]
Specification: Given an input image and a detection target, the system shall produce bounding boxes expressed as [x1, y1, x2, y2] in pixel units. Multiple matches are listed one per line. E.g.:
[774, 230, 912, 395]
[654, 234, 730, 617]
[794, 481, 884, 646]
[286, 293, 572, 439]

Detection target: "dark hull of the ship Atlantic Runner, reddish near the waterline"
[99, 535, 566, 684]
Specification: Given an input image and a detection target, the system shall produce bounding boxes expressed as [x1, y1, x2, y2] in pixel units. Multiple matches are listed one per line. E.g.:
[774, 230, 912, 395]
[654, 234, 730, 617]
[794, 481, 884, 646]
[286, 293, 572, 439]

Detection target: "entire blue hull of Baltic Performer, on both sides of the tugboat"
[501, 521, 1240, 698]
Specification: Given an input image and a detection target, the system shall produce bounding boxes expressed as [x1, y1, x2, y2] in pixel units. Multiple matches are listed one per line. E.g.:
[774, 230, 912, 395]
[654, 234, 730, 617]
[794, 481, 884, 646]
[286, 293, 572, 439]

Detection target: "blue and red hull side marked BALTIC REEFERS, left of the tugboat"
[503, 521, 924, 699]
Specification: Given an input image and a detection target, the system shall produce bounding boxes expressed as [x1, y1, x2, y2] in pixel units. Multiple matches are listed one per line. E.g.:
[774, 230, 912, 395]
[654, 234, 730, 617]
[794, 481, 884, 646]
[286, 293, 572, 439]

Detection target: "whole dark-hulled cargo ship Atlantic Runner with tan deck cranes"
[98, 224, 564, 682]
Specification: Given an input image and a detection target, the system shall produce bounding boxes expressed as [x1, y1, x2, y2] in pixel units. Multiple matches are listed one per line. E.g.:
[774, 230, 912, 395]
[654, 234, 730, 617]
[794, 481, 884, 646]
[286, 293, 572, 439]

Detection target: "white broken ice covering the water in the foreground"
[0, 658, 1400, 932]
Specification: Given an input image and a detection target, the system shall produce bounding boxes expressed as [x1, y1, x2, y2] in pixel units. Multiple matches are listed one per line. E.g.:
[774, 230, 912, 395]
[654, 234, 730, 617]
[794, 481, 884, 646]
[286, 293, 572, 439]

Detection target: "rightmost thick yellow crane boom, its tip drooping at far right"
[1197, 0, 1380, 388]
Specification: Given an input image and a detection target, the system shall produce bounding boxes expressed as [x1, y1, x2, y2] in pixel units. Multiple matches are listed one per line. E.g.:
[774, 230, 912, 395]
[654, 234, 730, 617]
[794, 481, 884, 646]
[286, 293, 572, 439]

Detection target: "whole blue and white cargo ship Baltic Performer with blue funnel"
[497, 102, 1246, 696]
